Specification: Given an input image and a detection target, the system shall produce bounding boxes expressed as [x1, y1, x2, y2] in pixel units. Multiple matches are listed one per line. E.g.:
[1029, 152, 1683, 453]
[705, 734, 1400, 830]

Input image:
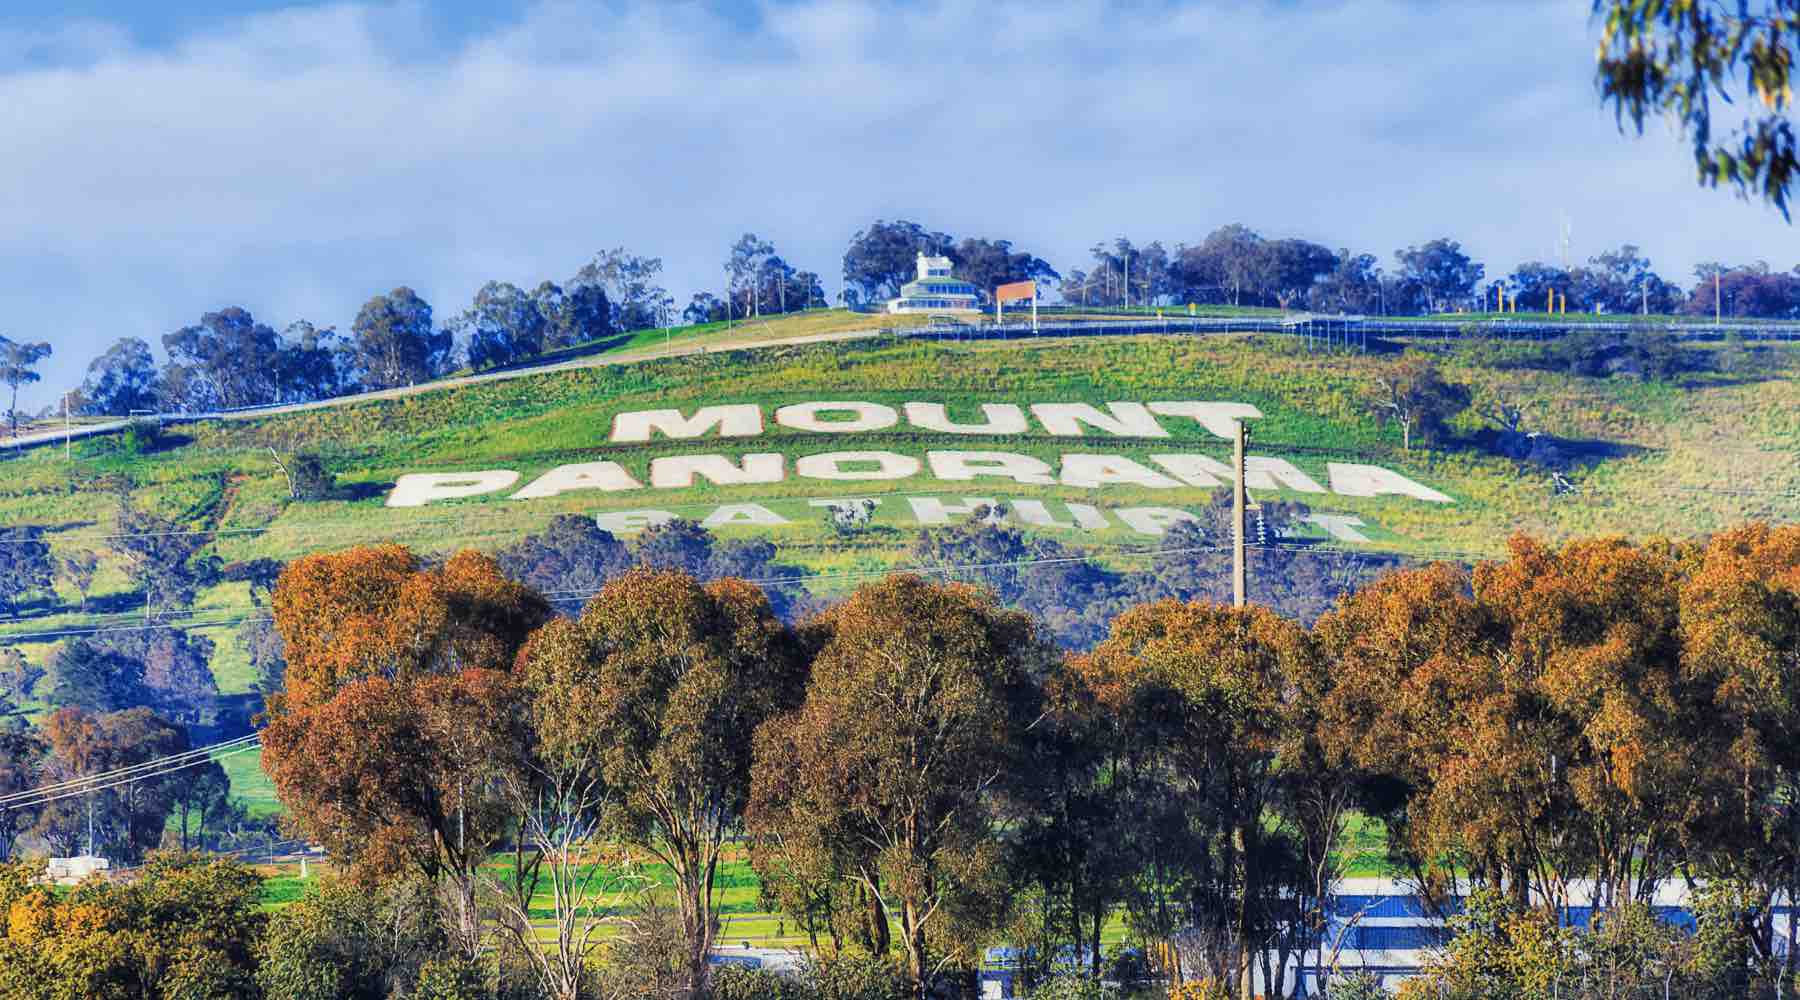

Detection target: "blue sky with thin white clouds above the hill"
[0, 0, 1800, 408]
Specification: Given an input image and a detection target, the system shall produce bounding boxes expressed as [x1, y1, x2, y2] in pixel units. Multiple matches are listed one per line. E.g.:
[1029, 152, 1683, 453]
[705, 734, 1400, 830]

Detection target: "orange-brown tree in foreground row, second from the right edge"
[1461, 538, 1710, 906]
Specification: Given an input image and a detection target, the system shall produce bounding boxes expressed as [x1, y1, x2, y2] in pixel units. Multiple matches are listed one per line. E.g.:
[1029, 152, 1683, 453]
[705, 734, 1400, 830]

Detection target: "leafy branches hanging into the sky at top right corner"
[1593, 0, 1800, 218]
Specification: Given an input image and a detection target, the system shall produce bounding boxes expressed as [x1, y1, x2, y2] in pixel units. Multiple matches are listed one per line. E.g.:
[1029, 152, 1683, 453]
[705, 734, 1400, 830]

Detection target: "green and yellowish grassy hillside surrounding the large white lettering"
[0, 327, 1800, 808]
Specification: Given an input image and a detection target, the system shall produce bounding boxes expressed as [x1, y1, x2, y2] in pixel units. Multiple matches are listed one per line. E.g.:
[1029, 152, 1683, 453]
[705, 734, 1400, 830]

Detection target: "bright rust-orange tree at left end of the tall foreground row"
[263, 545, 549, 955]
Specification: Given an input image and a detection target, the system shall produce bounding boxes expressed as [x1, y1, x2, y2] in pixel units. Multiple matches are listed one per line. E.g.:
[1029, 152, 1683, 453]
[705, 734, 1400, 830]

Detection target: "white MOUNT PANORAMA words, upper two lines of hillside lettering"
[387, 401, 1453, 527]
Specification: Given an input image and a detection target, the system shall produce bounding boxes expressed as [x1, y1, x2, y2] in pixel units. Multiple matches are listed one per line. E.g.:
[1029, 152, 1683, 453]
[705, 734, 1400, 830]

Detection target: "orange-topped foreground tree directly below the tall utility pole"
[1076, 601, 1318, 998]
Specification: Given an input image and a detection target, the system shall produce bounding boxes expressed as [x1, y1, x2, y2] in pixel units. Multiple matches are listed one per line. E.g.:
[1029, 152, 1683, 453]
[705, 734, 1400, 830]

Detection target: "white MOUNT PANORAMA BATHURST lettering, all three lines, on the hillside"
[387, 399, 1454, 541]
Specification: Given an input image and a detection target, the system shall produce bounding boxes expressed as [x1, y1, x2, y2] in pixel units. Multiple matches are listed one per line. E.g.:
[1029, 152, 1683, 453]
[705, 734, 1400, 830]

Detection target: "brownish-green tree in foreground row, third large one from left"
[751, 576, 1053, 996]
